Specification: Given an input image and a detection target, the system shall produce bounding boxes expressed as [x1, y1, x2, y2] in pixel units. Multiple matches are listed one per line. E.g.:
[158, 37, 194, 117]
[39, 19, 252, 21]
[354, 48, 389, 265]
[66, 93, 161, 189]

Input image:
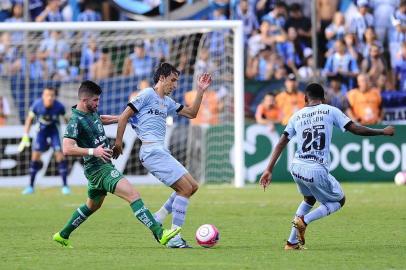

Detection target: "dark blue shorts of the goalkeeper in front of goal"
[32, 129, 62, 152]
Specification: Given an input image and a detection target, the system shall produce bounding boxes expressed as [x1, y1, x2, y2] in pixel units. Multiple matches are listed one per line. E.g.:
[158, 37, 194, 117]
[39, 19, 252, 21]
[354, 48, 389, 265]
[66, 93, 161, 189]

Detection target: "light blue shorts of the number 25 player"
[290, 163, 344, 203]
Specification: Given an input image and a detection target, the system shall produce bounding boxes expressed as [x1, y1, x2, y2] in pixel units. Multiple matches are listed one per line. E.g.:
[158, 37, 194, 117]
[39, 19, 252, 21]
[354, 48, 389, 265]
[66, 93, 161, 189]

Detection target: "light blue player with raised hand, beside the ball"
[113, 63, 212, 248]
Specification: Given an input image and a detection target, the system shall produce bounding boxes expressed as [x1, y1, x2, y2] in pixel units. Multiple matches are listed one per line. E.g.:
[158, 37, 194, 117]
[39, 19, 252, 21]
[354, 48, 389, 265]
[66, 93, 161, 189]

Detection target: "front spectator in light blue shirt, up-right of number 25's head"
[323, 40, 359, 89]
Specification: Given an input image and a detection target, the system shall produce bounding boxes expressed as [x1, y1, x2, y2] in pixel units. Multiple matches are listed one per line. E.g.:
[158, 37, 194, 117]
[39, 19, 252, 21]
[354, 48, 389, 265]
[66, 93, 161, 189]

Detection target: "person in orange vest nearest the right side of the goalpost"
[255, 92, 282, 131]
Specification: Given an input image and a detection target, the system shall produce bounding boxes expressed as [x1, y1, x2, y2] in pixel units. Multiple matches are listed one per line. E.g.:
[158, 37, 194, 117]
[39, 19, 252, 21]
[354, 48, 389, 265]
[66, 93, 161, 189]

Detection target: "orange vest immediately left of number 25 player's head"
[275, 91, 305, 126]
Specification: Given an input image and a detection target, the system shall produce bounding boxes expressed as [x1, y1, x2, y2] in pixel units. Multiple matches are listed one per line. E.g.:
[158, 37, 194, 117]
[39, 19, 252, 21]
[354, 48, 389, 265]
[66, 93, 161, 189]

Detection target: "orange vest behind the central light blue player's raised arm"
[185, 89, 224, 126]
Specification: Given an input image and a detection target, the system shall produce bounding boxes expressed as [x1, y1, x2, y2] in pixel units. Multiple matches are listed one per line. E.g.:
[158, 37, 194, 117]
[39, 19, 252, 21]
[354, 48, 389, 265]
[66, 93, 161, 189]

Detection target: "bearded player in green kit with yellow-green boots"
[53, 81, 180, 247]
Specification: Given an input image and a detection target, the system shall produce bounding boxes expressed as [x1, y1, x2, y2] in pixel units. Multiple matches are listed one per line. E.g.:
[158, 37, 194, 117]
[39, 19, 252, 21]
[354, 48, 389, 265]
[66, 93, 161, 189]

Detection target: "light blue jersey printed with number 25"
[284, 104, 351, 171]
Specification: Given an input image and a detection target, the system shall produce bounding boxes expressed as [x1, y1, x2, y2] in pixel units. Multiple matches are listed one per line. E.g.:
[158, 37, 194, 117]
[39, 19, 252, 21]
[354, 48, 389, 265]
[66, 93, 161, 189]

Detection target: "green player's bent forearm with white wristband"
[62, 138, 113, 162]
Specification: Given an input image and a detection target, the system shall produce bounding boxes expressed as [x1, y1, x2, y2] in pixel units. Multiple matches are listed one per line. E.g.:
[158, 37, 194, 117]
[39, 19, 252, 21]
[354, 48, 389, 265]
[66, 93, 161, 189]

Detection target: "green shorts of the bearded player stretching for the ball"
[85, 163, 124, 201]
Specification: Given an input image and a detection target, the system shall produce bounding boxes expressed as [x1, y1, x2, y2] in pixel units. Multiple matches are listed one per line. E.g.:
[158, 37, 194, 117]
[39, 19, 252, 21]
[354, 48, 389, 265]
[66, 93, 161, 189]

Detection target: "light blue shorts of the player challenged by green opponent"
[140, 143, 188, 186]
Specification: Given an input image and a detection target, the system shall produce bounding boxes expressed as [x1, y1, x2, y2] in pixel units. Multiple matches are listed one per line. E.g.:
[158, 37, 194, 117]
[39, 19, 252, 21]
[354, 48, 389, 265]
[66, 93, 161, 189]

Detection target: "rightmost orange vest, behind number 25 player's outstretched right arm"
[347, 88, 382, 125]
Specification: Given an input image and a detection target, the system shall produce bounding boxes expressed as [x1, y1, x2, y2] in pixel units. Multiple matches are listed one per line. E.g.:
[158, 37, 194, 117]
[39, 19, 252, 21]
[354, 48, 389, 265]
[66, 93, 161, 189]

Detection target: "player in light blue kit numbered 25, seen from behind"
[260, 83, 395, 250]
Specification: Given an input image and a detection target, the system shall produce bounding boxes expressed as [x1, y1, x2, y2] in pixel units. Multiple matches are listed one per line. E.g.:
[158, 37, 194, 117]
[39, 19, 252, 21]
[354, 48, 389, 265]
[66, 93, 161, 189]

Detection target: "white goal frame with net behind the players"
[0, 21, 244, 186]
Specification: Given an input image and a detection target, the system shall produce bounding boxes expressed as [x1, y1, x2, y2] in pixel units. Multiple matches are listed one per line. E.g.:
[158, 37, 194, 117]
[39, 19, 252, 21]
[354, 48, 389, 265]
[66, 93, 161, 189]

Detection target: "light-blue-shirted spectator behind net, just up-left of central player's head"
[123, 39, 156, 79]
